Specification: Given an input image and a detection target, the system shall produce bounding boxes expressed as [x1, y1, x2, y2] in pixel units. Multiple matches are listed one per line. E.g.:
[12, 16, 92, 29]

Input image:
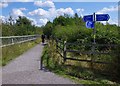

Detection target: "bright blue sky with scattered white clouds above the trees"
[0, 0, 118, 26]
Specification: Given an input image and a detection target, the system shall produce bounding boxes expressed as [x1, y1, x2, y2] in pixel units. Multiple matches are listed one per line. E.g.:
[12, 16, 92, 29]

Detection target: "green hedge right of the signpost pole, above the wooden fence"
[96, 23, 120, 44]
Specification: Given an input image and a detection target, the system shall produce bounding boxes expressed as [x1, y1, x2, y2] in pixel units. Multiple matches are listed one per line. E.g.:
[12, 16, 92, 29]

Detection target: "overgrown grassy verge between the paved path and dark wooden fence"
[42, 41, 120, 86]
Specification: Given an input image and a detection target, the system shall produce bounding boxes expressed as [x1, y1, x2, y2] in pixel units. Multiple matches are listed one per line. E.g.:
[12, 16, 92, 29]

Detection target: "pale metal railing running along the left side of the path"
[0, 35, 39, 47]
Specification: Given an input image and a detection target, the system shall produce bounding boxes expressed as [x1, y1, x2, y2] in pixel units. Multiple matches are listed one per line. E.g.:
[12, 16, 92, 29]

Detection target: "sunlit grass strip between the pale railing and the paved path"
[2, 39, 41, 66]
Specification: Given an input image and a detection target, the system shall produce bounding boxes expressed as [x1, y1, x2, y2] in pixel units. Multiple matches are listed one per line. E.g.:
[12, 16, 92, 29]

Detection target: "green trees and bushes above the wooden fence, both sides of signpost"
[43, 13, 120, 44]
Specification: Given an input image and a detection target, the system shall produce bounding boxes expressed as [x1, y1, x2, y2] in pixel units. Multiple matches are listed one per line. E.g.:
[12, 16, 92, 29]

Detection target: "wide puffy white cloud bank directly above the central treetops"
[28, 8, 74, 26]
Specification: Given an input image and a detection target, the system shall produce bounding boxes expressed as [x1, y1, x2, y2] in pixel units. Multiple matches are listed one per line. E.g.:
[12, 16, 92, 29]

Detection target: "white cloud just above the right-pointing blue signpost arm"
[97, 6, 118, 14]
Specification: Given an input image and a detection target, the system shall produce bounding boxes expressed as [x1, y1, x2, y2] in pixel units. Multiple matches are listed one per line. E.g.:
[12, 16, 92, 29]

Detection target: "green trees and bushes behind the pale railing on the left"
[2, 16, 42, 36]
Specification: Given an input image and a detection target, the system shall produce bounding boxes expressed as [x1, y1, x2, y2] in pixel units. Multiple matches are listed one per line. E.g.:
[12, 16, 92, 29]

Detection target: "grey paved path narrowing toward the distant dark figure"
[2, 44, 74, 84]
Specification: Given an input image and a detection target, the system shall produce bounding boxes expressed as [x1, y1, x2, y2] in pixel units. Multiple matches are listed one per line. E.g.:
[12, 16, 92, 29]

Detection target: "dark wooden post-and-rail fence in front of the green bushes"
[56, 39, 118, 64]
